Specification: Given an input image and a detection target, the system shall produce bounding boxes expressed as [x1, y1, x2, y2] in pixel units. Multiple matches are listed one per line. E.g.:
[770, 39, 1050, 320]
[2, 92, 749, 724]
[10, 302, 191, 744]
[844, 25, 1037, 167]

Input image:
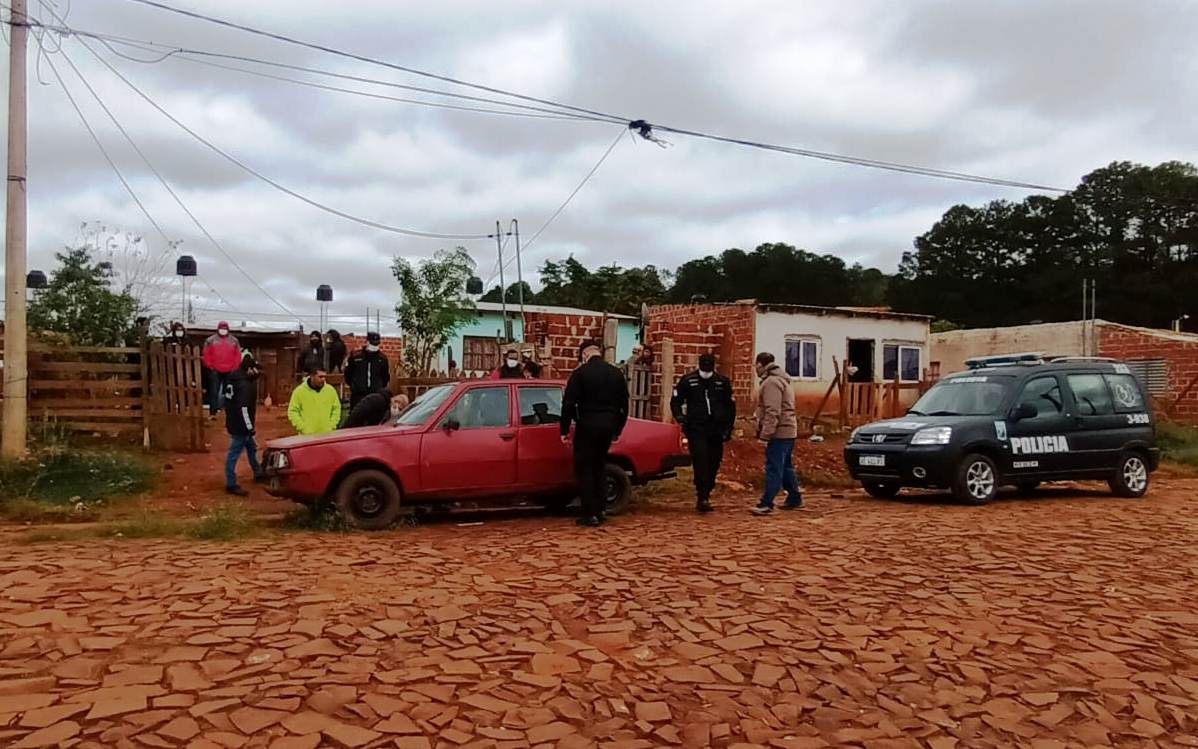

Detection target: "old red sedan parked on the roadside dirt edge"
[264, 380, 690, 530]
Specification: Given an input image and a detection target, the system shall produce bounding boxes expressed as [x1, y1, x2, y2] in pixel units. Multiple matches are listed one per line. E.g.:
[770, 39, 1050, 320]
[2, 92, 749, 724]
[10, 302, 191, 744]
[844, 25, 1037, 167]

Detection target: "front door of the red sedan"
[420, 385, 518, 495]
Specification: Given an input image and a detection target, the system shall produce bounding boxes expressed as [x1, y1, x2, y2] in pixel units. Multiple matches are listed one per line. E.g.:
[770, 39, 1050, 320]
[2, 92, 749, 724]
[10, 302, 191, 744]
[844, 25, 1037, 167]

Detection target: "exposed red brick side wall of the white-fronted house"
[645, 304, 757, 417]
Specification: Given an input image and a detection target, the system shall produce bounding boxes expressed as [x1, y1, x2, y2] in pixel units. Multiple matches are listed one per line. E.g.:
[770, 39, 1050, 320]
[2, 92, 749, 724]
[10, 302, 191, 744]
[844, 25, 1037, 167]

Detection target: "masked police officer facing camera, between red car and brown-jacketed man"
[670, 354, 737, 513]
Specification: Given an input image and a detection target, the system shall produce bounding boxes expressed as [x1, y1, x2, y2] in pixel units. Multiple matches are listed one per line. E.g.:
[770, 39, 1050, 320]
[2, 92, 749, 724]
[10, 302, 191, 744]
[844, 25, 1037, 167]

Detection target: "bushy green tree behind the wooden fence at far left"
[29, 247, 138, 346]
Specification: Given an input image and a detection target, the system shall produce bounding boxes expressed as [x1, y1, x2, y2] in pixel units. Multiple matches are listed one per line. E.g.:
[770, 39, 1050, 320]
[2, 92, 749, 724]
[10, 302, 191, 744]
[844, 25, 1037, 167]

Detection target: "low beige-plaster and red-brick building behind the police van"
[932, 320, 1198, 424]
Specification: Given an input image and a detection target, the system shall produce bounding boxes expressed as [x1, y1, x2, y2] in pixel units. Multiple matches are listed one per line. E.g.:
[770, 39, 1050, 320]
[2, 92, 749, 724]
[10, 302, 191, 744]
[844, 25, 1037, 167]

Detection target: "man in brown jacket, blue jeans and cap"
[752, 352, 803, 515]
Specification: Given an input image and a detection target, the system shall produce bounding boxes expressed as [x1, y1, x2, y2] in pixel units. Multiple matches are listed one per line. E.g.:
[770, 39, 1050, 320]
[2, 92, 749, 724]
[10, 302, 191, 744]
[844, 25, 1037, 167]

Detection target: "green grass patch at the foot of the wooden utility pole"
[0, 448, 156, 523]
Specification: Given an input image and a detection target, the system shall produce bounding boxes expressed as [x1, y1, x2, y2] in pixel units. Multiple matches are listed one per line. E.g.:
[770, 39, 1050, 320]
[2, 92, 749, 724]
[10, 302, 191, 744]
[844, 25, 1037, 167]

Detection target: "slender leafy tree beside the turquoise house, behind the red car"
[391, 247, 477, 372]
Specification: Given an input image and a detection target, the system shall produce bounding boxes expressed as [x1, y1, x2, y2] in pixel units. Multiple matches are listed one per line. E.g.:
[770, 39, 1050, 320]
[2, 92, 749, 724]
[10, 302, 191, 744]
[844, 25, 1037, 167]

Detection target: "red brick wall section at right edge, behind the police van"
[1099, 322, 1198, 423]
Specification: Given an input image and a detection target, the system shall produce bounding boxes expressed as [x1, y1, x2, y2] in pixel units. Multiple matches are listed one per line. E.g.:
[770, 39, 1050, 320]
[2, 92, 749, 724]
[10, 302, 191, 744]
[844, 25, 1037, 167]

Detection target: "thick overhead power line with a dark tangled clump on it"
[116, 0, 1069, 193]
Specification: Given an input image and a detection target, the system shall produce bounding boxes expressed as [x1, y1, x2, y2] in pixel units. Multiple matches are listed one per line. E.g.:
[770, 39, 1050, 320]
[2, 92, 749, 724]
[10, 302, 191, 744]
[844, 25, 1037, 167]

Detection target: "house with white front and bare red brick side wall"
[645, 301, 931, 415]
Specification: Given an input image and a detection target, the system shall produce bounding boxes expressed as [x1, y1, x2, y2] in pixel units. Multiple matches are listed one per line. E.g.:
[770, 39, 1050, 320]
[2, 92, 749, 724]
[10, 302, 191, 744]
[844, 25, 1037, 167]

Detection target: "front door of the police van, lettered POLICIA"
[1003, 374, 1075, 478]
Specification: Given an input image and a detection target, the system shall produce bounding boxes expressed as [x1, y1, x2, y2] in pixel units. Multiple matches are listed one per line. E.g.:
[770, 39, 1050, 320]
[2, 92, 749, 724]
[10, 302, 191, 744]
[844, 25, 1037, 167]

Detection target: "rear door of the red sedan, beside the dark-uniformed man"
[516, 385, 574, 491]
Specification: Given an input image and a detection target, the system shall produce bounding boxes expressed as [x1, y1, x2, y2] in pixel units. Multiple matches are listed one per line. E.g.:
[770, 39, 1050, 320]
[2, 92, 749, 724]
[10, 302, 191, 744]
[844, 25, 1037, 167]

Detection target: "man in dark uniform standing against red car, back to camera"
[562, 340, 628, 527]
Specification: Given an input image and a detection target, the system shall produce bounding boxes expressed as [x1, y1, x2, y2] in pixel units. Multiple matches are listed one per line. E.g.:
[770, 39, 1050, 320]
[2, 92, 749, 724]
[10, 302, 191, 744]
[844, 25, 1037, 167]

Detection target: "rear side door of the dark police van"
[1065, 373, 1142, 473]
